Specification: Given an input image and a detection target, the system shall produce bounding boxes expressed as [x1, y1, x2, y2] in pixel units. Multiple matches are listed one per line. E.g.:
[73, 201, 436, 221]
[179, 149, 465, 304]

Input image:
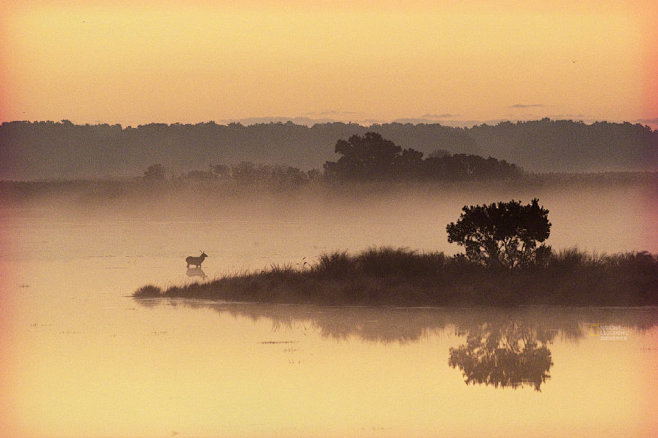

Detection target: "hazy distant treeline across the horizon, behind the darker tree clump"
[0, 119, 658, 180]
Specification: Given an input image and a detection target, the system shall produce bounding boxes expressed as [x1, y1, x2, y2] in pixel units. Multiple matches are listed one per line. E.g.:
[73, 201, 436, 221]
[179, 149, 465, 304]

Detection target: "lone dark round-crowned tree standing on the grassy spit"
[446, 198, 551, 268]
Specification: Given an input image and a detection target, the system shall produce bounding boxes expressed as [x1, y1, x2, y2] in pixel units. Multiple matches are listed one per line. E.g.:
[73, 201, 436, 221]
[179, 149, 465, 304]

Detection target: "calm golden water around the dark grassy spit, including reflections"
[0, 199, 658, 438]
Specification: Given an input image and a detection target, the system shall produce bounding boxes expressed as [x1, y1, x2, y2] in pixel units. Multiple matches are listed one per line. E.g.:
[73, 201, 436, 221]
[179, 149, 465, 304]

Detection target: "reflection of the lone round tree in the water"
[448, 321, 557, 391]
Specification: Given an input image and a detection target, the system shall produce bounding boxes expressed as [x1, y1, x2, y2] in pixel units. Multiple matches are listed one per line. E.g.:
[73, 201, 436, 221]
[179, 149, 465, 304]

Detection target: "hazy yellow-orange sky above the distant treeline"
[0, 0, 658, 125]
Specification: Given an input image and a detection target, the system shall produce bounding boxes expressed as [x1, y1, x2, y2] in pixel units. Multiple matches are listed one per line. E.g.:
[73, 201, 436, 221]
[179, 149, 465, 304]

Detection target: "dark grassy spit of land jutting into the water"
[133, 248, 658, 306]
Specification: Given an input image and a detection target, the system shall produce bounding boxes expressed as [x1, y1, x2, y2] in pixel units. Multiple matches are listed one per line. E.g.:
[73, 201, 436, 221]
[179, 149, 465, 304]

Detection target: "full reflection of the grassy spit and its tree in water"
[137, 298, 658, 391]
